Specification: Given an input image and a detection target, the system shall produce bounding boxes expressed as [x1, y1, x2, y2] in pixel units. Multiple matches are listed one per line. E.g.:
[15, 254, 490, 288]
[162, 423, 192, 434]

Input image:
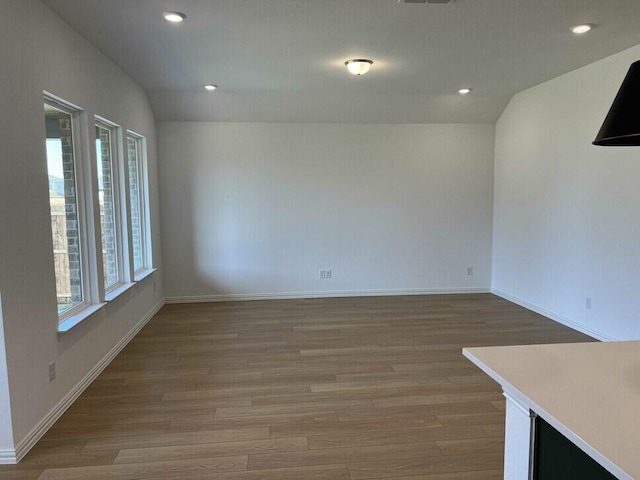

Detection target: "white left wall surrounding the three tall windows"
[0, 0, 162, 460]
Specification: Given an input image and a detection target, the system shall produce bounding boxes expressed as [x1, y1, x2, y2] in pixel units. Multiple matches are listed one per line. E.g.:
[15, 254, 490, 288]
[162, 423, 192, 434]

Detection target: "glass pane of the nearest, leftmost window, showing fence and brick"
[44, 104, 83, 314]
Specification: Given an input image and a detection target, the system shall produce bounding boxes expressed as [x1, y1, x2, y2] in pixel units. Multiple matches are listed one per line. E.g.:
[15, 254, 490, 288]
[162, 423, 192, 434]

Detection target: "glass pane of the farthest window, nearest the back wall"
[127, 136, 146, 272]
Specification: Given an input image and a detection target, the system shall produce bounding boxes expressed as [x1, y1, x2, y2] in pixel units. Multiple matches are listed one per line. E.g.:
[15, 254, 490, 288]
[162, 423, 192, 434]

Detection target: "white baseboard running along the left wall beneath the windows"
[0, 299, 165, 464]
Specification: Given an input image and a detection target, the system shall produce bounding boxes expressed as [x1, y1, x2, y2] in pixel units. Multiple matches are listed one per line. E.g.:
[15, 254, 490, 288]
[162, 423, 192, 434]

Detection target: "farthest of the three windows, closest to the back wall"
[127, 132, 151, 273]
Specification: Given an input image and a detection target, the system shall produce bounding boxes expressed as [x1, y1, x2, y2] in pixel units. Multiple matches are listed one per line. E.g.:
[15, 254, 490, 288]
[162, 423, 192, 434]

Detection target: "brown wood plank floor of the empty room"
[0, 294, 592, 480]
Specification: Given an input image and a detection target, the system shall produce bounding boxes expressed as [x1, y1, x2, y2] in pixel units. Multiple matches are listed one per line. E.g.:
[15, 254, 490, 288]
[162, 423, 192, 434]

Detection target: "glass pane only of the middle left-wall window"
[96, 126, 120, 290]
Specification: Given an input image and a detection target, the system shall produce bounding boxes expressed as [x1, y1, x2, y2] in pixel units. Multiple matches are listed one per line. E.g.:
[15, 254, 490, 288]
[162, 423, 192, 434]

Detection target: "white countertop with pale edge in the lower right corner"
[463, 342, 640, 479]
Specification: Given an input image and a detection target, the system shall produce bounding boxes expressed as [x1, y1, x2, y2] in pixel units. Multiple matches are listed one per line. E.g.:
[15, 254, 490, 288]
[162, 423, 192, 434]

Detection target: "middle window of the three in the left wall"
[96, 121, 122, 293]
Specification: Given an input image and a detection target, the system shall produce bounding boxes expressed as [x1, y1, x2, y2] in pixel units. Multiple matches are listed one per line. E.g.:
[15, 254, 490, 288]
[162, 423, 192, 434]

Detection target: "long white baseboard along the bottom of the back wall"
[165, 288, 490, 304]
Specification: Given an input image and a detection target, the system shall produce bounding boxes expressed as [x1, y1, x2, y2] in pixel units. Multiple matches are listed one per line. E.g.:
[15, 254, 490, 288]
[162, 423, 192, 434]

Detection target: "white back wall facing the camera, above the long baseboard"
[158, 122, 494, 300]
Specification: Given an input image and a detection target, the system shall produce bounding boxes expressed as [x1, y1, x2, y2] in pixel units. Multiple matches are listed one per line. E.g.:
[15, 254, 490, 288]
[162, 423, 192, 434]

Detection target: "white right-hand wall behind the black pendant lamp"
[493, 43, 640, 340]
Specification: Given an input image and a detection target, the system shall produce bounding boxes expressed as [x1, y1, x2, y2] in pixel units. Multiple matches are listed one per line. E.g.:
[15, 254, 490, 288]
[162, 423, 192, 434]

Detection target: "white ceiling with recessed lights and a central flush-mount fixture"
[43, 0, 640, 123]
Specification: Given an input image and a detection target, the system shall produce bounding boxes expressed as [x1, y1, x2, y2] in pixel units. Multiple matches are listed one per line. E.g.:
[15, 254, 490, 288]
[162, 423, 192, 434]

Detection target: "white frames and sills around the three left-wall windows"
[42, 91, 155, 336]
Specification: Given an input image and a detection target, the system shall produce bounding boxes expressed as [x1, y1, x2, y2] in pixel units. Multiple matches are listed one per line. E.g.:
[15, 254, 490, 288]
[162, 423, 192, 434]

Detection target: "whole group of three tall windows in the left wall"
[44, 92, 153, 332]
